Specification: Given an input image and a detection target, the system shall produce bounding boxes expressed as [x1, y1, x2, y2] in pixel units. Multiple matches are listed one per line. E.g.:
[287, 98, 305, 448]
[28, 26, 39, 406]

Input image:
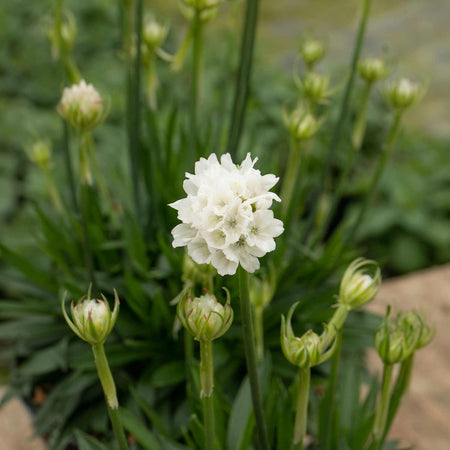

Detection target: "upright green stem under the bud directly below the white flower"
[200, 341, 215, 450]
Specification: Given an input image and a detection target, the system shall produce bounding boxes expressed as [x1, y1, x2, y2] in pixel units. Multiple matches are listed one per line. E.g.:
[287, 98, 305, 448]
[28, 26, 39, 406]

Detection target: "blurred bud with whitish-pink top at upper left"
[57, 80, 107, 132]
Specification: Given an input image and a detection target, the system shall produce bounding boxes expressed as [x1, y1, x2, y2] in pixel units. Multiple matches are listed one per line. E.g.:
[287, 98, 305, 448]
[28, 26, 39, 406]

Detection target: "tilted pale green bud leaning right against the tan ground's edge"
[338, 258, 381, 309]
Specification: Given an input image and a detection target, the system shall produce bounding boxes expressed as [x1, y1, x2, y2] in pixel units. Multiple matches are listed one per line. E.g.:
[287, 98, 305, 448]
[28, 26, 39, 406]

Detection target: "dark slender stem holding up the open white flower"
[239, 267, 269, 450]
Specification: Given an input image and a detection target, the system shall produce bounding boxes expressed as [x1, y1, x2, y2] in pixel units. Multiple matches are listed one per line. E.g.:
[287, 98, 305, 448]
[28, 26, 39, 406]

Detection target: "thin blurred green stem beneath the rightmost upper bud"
[348, 111, 402, 239]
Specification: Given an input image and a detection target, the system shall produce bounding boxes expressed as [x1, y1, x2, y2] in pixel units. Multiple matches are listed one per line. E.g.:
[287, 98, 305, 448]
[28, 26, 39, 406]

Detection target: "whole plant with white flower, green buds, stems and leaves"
[0, 0, 433, 450]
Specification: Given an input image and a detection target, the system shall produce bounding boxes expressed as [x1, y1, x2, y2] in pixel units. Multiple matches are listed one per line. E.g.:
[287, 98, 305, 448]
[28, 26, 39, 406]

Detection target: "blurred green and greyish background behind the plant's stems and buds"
[0, 0, 450, 275]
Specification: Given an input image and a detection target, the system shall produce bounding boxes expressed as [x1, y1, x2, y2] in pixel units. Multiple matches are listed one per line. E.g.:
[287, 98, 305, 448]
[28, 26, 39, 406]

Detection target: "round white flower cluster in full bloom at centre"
[169, 153, 283, 275]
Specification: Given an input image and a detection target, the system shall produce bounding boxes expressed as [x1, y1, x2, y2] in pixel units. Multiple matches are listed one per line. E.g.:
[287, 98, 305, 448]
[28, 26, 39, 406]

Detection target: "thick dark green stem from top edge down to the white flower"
[227, 0, 259, 157]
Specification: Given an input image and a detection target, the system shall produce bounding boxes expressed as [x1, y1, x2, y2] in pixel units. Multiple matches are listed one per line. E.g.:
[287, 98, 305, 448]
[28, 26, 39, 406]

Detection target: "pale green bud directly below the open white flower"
[177, 291, 233, 341]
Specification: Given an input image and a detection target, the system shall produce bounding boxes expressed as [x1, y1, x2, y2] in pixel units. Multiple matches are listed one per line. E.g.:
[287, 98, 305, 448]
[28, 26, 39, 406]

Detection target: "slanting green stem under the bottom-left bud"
[92, 344, 128, 450]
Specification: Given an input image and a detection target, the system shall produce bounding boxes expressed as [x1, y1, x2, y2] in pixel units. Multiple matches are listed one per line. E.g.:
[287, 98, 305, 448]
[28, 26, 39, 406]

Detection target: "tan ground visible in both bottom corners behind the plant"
[0, 265, 450, 450]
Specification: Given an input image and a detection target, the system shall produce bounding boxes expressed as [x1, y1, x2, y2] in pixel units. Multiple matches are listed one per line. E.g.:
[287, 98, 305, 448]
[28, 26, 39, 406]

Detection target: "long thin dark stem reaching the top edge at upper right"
[308, 0, 372, 239]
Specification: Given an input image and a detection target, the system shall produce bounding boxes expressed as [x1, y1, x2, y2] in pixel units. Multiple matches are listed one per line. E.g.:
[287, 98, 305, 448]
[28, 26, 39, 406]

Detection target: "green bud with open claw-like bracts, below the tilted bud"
[281, 302, 336, 369]
